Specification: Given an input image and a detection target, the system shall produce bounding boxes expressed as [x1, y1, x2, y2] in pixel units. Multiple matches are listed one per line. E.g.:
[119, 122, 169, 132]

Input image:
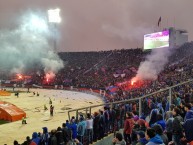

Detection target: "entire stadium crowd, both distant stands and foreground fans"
[2, 42, 193, 145]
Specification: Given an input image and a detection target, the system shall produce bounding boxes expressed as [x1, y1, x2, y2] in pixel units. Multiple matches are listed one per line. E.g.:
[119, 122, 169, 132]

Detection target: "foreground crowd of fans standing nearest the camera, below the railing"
[14, 99, 193, 145]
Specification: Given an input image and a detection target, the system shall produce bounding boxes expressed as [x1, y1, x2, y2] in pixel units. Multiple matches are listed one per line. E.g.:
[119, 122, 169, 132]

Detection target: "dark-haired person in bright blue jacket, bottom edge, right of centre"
[145, 128, 164, 145]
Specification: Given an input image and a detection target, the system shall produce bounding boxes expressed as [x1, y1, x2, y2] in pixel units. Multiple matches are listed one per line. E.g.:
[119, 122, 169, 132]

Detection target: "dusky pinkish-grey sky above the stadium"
[0, 0, 193, 51]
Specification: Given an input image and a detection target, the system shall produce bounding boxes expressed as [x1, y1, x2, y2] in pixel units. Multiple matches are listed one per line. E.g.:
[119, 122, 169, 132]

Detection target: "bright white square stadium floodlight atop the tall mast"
[48, 8, 61, 23]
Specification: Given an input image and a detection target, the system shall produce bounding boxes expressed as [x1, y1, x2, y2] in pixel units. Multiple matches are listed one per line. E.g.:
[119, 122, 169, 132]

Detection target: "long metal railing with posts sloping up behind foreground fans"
[68, 79, 193, 120]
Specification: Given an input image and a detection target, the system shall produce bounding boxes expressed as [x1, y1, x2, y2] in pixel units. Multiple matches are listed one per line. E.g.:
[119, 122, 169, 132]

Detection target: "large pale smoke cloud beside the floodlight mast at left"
[0, 12, 63, 76]
